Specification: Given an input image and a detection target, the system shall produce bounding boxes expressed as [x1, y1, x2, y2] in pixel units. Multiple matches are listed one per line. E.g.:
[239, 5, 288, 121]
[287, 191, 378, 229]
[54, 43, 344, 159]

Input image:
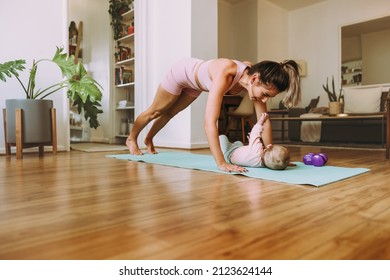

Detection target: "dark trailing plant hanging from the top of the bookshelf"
[108, 0, 133, 40]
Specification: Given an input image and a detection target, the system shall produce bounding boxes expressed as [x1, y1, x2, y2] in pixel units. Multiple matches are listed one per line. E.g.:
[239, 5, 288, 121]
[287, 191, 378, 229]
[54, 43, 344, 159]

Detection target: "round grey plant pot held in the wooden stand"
[5, 99, 53, 144]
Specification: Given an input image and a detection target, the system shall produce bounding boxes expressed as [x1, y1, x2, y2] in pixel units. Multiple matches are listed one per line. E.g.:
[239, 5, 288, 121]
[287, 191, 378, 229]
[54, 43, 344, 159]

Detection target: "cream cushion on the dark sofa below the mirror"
[343, 87, 382, 113]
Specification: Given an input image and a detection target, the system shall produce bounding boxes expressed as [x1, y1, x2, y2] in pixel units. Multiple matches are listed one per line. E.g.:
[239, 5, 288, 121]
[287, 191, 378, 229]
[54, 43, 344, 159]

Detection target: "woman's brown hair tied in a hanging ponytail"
[248, 60, 301, 108]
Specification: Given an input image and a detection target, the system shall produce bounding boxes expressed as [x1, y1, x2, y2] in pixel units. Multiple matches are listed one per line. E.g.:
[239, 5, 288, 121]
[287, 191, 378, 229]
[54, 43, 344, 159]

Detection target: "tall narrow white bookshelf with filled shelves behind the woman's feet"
[111, 4, 136, 144]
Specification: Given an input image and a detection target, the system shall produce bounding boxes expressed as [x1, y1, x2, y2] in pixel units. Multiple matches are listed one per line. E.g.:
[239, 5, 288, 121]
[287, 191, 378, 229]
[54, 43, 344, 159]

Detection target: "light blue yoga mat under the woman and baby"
[107, 151, 370, 187]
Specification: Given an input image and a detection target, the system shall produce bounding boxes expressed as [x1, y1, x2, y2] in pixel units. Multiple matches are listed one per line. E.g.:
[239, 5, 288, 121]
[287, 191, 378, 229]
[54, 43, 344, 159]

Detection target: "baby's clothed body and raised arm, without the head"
[219, 123, 265, 167]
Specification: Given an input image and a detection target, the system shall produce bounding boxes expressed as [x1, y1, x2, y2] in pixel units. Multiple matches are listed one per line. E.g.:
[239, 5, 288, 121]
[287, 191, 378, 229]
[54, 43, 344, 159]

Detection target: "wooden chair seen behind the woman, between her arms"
[225, 94, 255, 143]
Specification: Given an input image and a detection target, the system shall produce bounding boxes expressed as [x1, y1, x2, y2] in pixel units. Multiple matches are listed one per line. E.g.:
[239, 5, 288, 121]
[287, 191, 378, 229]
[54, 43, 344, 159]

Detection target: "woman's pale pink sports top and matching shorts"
[161, 58, 248, 97]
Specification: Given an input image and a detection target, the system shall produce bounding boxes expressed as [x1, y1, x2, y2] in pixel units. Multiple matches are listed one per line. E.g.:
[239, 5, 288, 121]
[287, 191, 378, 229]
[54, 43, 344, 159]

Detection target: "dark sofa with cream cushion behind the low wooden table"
[288, 87, 390, 144]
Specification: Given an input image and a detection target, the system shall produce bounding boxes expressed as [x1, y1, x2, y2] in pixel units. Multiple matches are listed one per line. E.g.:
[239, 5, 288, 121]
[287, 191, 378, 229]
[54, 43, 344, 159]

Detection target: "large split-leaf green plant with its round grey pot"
[0, 47, 103, 143]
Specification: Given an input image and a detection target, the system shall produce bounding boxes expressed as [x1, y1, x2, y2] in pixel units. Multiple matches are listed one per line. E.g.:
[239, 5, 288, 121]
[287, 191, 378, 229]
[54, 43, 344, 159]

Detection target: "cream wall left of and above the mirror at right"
[288, 0, 390, 106]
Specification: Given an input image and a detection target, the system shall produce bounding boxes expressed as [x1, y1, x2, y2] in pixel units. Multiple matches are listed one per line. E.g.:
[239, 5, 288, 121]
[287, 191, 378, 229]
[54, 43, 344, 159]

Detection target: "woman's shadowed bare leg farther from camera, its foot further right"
[144, 93, 197, 154]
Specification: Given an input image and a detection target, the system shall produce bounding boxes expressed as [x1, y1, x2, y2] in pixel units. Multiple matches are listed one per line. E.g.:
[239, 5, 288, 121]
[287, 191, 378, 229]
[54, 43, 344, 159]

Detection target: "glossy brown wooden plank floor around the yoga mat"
[0, 144, 390, 259]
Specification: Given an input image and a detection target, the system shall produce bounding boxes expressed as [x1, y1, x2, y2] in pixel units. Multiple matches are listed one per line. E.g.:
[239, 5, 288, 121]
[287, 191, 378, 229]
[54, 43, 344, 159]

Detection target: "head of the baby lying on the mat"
[264, 145, 290, 170]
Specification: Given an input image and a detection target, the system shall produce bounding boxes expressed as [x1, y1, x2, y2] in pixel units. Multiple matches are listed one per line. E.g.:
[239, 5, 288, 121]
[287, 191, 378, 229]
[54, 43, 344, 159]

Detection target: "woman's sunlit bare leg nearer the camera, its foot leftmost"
[126, 86, 180, 155]
